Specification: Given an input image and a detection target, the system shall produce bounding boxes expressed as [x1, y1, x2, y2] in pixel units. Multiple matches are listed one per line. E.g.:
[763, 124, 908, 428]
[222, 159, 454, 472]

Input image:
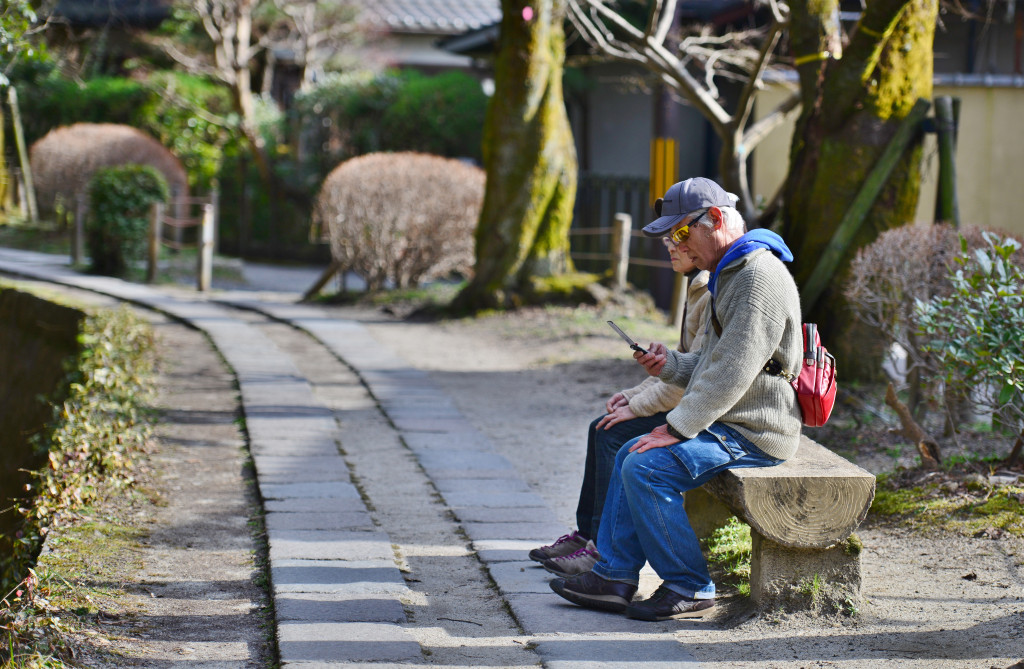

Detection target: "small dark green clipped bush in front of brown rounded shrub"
[86, 165, 169, 277]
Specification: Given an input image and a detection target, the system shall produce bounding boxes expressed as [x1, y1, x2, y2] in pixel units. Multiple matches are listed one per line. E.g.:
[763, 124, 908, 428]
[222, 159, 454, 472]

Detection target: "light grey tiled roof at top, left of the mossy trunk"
[364, 0, 502, 35]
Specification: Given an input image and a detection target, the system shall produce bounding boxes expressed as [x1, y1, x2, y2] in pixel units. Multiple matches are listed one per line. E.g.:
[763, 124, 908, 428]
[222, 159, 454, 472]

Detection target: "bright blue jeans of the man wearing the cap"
[594, 423, 781, 599]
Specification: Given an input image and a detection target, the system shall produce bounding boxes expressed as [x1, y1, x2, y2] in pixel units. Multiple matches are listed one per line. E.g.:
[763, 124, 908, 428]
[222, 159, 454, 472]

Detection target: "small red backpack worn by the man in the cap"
[711, 311, 839, 427]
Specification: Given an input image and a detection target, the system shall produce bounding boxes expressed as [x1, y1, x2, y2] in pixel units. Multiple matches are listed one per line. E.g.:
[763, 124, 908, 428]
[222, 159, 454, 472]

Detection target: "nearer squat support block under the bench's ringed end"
[751, 528, 861, 614]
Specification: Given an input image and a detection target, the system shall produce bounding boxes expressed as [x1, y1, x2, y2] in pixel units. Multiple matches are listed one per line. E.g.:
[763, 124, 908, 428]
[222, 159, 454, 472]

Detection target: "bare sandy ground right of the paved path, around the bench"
[354, 301, 1024, 669]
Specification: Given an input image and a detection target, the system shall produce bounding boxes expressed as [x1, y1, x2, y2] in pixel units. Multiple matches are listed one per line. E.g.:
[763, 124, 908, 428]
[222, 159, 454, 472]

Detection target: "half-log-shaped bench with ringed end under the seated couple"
[685, 436, 874, 610]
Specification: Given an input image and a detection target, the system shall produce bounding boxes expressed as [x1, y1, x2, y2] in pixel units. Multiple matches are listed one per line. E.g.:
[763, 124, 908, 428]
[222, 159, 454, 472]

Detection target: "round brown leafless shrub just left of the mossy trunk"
[314, 153, 484, 290]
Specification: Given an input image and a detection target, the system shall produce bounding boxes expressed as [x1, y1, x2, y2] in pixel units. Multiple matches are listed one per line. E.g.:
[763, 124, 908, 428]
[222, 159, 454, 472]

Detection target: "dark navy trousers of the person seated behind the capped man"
[577, 411, 668, 543]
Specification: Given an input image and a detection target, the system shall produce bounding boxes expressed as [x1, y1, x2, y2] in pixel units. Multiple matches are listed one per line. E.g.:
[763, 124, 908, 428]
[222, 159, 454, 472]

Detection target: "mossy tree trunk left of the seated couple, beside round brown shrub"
[454, 0, 577, 310]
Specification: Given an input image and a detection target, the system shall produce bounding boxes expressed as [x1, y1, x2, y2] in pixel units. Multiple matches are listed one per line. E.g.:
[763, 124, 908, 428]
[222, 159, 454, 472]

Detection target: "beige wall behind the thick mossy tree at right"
[752, 85, 1024, 237]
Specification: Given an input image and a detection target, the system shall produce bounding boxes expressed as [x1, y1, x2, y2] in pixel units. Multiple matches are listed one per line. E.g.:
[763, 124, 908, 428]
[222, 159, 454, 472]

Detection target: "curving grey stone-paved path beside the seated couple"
[0, 249, 697, 669]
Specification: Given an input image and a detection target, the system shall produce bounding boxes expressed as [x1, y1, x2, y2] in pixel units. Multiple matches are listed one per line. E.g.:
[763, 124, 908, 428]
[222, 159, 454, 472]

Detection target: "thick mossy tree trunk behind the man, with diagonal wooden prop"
[780, 0, 938, 376]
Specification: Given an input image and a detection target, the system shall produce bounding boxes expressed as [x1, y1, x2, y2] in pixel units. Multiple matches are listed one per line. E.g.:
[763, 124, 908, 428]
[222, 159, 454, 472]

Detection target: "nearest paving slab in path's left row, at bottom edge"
[278, 622, 423, 666]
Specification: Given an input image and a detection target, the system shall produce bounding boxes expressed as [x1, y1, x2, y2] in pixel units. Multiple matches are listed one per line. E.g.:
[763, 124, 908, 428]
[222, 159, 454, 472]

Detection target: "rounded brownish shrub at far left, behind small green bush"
[31, 123, 188, 214]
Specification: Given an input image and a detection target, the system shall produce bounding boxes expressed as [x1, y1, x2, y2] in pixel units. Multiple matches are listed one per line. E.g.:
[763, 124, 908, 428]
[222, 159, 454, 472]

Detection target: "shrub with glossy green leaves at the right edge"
[918, 233, 1024, 456]
